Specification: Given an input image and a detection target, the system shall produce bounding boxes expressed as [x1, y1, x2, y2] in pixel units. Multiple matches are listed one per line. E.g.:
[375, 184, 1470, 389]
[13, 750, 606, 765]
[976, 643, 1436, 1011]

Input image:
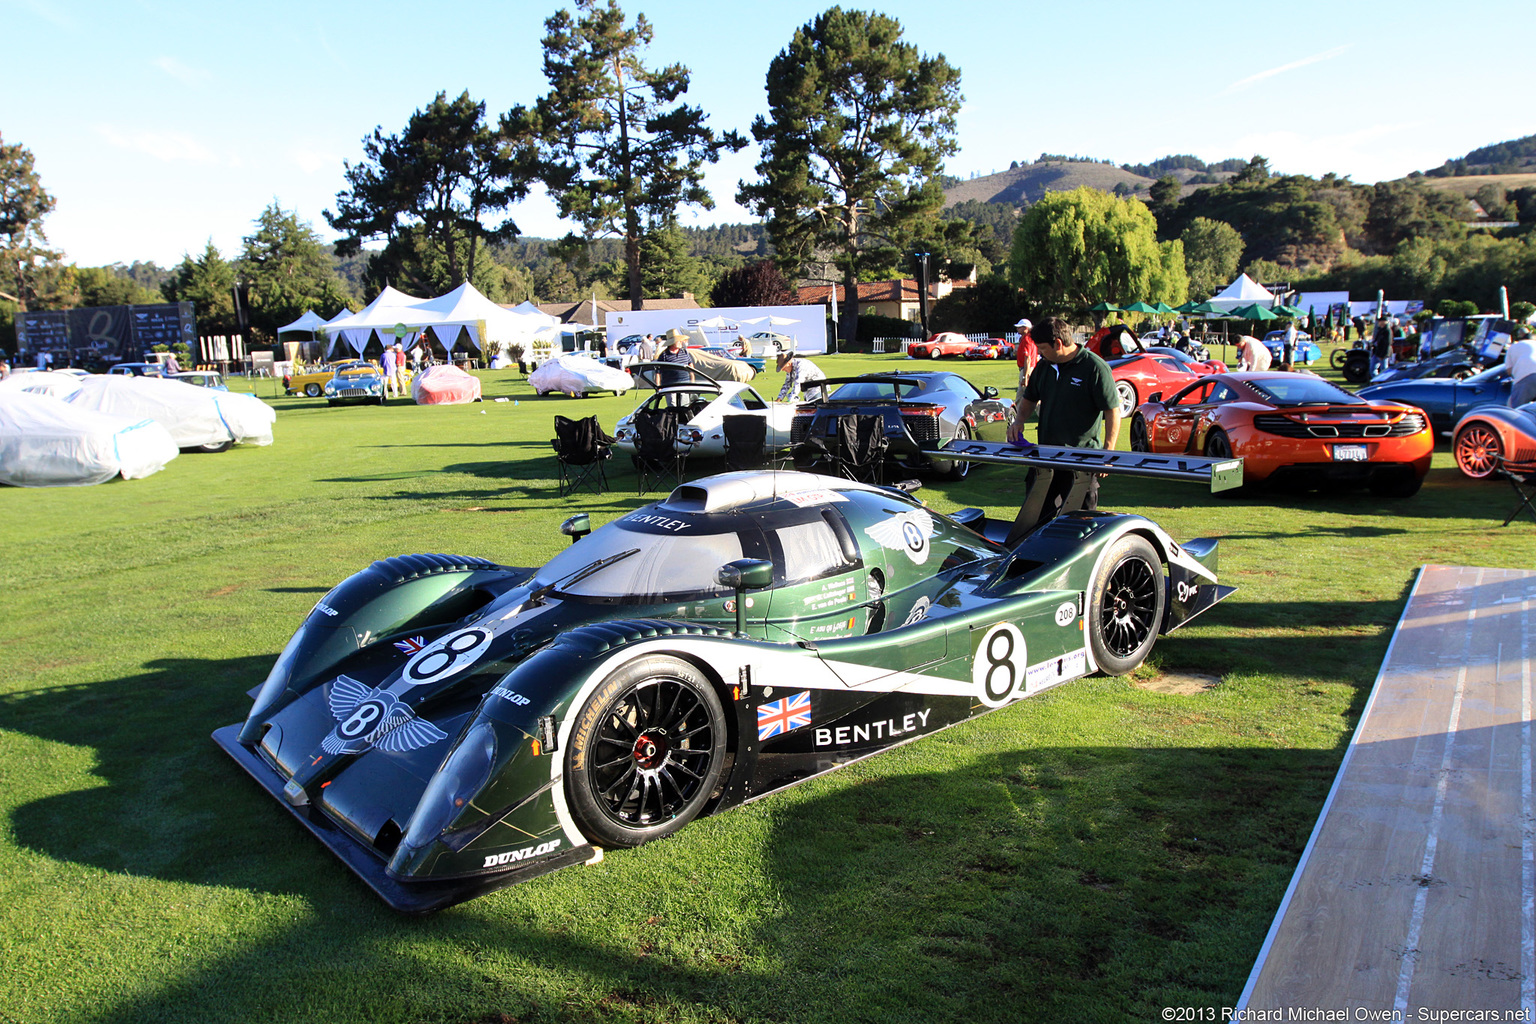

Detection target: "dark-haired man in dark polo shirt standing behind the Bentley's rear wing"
[1008, 316, 1120, 542]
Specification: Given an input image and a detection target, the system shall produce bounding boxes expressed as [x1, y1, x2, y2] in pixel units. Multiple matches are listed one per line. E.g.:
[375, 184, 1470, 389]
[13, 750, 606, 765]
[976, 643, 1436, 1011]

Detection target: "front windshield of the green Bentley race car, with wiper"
[535, 524, 743, 595]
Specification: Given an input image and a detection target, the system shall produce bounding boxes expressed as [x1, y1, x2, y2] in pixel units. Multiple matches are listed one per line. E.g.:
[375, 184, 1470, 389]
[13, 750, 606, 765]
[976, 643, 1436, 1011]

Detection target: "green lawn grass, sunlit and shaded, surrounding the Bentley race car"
[0, 356, 1536, 1024]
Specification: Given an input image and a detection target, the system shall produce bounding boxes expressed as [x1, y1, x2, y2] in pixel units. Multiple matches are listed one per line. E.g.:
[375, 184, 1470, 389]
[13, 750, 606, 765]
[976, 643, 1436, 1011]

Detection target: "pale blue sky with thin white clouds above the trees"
[0, 0, 1536, 266]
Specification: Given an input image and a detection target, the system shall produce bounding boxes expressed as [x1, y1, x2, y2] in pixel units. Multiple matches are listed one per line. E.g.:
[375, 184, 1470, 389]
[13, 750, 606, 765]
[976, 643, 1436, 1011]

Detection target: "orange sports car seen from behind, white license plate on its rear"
[1130, 372, 1435, 497]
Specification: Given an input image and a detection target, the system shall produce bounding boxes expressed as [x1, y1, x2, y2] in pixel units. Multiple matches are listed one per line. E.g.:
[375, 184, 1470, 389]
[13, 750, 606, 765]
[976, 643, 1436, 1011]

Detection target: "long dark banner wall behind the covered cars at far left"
[17, 302, 197, 368]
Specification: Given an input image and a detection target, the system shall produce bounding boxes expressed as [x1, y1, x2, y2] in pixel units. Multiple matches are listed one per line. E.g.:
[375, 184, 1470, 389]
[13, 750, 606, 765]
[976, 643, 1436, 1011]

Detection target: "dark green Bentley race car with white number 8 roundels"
[214, 442, 1236, 912]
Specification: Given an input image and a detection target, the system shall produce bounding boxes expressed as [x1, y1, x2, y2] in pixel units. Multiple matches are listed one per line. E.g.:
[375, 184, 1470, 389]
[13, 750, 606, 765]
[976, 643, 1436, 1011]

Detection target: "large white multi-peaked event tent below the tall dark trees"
[323, 282, 561, 362]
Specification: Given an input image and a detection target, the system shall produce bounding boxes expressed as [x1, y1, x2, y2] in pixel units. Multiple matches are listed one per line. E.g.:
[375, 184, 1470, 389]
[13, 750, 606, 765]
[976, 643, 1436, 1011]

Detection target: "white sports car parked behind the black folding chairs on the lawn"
[613, 362, 796, 457]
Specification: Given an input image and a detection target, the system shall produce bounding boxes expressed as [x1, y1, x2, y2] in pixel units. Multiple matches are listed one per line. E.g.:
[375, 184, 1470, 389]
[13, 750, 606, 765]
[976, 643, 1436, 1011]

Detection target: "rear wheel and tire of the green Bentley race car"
[1087, 533, 1167, 676]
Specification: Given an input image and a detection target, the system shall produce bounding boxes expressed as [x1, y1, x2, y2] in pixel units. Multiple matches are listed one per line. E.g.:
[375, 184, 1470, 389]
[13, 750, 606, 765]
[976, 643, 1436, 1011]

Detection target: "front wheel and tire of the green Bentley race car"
[565, 656, 725, 846]
